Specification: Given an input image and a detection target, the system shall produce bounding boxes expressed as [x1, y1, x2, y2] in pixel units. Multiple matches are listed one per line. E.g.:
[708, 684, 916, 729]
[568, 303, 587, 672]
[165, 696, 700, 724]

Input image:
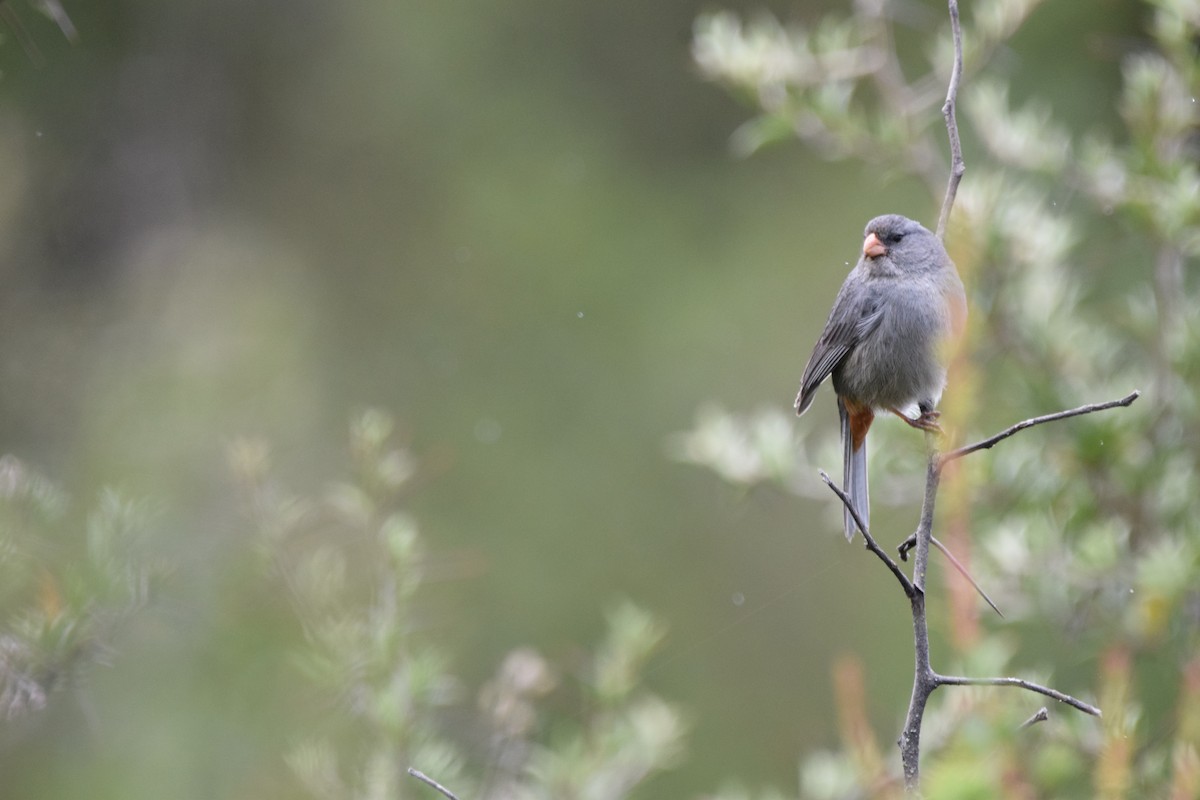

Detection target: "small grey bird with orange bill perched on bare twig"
[796, 213, 967, 541]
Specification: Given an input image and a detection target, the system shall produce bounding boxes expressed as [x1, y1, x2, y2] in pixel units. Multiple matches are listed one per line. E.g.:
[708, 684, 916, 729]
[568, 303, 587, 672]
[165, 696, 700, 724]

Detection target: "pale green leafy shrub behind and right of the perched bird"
[673, 0, 1200, 798]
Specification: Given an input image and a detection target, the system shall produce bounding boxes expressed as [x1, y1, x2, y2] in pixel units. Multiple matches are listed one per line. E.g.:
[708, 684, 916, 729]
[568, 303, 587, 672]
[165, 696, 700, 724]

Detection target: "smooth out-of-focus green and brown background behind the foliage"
[0, 0, 1161, 798]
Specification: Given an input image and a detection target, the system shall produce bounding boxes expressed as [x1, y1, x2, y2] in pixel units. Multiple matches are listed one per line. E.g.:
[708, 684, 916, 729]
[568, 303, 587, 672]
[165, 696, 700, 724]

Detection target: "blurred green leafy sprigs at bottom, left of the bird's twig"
[230, 411, 684, 800]
